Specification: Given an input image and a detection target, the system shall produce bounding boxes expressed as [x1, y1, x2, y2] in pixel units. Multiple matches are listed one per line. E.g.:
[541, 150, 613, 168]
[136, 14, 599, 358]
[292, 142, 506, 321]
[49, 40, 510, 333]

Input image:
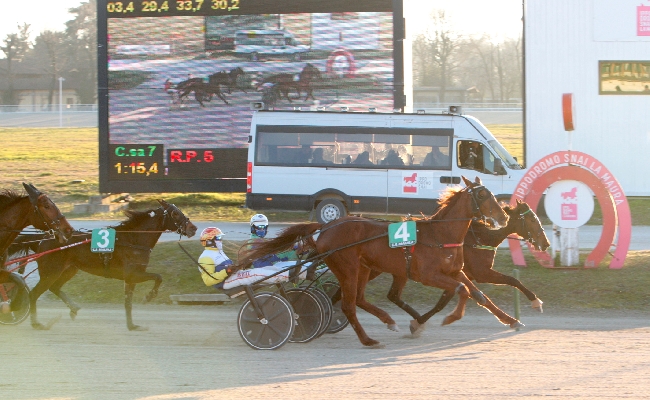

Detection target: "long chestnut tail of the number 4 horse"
[235, 222, 323, 269]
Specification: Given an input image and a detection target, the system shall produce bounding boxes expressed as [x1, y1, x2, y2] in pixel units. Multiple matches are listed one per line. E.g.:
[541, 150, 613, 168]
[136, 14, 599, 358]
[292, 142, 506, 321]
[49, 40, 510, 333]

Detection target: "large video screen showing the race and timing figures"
[98, 0, 403, 193]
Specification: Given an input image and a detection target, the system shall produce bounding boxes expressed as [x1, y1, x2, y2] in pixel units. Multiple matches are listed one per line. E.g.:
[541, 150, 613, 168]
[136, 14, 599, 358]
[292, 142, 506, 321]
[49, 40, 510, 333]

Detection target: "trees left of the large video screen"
[0, 0, 97, 105]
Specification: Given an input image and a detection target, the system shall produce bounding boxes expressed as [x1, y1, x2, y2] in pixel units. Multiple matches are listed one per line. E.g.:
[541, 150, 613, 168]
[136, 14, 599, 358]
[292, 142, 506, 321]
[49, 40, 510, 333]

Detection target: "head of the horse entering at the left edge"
[23, 182, 74, 243]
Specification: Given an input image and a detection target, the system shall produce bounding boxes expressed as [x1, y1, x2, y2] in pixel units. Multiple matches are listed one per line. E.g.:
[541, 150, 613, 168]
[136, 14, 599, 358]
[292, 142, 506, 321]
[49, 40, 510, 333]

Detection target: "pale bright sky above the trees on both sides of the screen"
[0, 0, 522, 44]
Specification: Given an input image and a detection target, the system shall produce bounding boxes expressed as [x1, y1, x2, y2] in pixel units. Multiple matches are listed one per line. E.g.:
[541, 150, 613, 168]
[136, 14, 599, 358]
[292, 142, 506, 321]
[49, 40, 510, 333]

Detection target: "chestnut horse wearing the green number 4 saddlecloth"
[241, 177, 508, 346]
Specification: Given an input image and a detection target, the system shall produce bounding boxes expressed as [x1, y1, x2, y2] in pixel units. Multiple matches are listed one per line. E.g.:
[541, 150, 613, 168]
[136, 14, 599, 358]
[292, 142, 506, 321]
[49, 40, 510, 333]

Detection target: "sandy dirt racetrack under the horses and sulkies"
[0, 301, 650, 400]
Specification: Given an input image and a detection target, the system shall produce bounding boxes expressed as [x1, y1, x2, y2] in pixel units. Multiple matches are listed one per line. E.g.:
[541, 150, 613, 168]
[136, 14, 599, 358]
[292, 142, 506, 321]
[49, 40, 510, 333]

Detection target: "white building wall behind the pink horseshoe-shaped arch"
[525, 0, 650, 196]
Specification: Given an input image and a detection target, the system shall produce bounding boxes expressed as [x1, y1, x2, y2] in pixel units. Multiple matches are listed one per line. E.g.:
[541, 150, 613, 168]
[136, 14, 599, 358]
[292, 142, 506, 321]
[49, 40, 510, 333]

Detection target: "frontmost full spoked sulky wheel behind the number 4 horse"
[237, 292, 294, 350]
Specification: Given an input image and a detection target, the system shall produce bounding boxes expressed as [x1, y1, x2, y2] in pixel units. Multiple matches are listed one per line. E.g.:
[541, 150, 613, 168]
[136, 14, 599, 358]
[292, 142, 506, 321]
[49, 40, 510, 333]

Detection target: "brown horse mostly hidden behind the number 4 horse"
[372, 200, 550, 334]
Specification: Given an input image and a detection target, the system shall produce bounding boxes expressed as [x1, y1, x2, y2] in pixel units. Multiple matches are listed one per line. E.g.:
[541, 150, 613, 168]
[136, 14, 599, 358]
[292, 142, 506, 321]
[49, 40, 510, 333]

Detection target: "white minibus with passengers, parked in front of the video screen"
[246, 110, 524, 223]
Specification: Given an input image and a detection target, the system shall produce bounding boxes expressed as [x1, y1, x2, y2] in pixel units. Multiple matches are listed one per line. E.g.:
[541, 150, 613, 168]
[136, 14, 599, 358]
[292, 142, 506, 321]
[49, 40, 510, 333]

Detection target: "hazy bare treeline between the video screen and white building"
[413, 10, 523, 103]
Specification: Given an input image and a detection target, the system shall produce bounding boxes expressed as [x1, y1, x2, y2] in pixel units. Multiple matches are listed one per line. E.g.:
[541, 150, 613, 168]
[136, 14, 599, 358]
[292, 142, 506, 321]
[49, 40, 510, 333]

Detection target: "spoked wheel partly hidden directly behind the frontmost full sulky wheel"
[286, 288, 324, 343]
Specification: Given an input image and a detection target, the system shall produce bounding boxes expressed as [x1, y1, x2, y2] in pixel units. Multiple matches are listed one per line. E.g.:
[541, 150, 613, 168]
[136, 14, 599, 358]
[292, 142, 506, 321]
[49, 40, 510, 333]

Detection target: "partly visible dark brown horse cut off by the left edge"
[0, 183, 74, 311]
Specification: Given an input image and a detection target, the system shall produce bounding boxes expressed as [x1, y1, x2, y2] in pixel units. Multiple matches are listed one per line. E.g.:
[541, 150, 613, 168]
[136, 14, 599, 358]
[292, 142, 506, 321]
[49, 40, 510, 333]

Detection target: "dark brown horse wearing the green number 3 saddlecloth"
[15, 200, 197, 330]
